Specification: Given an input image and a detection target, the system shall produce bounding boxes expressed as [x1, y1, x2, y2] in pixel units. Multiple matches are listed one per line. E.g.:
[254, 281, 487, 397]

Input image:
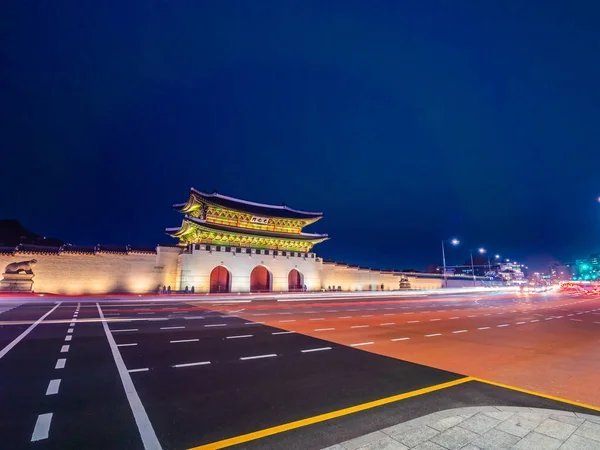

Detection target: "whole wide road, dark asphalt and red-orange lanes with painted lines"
[0, 292, 600, 449]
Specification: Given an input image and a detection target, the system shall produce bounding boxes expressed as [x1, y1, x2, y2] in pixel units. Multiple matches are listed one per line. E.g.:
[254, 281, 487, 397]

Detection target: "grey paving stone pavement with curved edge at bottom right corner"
[323, 406, 600, 450]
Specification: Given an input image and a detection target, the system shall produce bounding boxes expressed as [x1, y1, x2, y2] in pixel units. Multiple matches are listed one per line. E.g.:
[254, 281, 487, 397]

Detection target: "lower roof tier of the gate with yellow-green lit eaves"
[166, 216, 328, 252]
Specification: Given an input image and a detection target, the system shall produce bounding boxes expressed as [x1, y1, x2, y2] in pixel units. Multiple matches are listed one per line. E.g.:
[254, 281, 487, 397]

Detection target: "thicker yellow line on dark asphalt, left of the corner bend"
[189, 377, 473, 450]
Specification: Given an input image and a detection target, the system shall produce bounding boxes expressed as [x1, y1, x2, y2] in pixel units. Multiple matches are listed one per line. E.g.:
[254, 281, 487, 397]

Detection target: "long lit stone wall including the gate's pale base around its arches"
[0, 245, 492, 295]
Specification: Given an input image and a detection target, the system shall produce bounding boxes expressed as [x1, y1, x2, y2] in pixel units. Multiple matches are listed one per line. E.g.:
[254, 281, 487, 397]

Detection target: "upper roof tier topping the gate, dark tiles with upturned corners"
[173, 188, 323, 223]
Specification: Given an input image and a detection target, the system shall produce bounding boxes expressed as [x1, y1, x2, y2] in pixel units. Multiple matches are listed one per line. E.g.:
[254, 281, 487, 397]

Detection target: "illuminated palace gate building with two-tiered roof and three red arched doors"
[166, 188, 327, 293]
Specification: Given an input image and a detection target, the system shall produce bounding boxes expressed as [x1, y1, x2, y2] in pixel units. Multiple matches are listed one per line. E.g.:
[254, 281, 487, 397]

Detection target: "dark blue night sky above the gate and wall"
[0, 0, 600, 268]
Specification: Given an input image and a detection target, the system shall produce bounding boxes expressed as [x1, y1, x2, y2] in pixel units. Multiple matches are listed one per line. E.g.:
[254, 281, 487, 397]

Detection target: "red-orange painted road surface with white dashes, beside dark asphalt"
[231, 295, 600, 406]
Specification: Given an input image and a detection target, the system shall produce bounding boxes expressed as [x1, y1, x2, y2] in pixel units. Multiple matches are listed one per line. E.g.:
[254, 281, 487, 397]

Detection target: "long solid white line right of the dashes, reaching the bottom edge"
[96, 303, 162, 450]
